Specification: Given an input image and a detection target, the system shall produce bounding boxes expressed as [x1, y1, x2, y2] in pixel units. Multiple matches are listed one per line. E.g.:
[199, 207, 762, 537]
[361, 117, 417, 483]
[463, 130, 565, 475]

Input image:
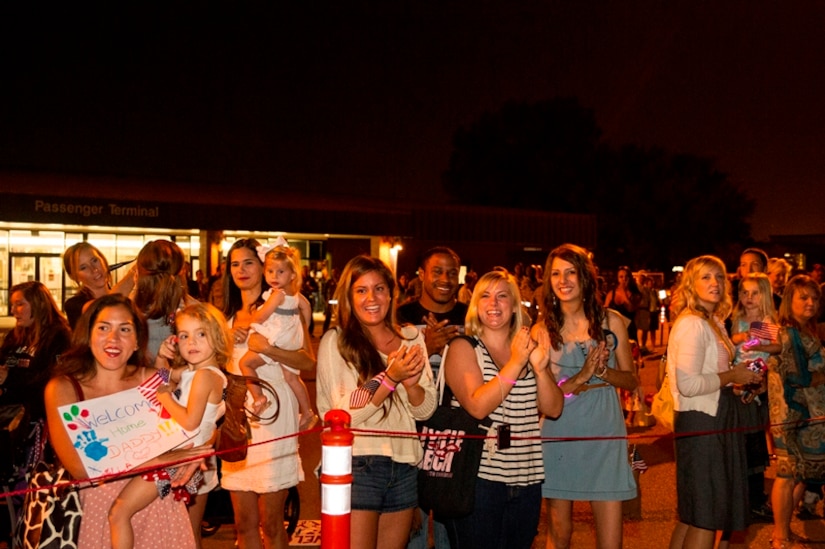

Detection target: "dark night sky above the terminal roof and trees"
[0, 0, 825, 238]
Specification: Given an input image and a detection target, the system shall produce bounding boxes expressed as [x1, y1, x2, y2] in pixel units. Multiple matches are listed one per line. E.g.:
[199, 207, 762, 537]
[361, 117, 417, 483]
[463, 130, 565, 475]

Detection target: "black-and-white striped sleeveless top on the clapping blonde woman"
[452, 338, 544, 486]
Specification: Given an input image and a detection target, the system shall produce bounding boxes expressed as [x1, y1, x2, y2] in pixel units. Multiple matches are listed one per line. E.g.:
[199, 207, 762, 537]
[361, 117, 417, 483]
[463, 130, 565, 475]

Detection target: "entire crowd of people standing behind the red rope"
[0, 239, 825, 549]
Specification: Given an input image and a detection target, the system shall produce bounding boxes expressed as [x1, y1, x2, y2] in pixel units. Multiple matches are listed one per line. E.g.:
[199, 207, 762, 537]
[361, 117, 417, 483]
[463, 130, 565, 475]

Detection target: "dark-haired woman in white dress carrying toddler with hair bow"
[221, 238, 315, 549]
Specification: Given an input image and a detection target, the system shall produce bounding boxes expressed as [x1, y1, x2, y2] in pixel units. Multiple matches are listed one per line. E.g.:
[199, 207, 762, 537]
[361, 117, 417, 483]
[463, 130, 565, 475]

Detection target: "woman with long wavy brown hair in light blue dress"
[533, 244, 638, 549]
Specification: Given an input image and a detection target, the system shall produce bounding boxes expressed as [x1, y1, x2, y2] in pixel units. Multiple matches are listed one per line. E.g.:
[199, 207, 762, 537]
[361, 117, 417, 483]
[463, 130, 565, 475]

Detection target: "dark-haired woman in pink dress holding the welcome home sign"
[45, 294, 205, 549]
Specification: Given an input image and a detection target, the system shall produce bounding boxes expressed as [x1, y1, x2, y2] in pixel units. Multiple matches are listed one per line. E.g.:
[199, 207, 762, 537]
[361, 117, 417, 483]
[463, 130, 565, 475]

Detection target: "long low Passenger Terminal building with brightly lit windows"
[0, 173, 596, 315]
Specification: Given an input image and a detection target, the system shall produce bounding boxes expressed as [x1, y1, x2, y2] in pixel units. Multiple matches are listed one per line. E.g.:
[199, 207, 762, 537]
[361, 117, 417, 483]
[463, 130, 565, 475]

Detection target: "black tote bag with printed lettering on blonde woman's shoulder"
[418, 336, 493, 520]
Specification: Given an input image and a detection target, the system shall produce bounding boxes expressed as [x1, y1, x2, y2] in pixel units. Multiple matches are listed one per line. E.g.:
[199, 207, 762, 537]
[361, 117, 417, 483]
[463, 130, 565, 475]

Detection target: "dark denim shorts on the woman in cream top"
[352, 456, 418, 513]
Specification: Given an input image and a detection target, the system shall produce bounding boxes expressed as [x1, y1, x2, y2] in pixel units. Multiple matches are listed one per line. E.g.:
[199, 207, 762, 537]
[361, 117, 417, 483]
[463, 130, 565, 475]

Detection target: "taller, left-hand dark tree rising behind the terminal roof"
[444, 99, 601, 212]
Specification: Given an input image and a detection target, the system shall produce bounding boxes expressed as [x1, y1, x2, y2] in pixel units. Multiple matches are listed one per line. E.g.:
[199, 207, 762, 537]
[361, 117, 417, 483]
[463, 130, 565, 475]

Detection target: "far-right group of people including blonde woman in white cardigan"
[667, 248, 825, 549]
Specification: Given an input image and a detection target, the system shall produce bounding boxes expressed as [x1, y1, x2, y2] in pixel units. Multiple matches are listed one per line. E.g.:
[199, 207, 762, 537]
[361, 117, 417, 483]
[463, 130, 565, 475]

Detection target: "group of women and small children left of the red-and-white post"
[0, 239, 317, 548]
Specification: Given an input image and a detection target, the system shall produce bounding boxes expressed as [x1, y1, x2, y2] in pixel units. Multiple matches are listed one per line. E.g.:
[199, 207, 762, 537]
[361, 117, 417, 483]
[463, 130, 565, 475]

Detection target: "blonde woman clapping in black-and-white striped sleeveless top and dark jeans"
[444, 271, 564, 549]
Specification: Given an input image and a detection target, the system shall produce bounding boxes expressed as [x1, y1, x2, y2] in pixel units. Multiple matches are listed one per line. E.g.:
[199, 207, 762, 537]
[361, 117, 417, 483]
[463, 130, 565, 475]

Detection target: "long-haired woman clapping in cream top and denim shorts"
[318, 255, 436, 549]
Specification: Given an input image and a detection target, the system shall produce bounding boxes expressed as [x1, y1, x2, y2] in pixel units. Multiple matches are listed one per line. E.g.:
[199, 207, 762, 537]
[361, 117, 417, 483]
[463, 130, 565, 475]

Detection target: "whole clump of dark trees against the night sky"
[443, 98, 754, 270]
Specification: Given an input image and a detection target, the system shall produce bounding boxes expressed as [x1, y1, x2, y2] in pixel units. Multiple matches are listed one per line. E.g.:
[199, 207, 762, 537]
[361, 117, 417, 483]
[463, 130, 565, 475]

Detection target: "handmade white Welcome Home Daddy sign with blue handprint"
[58, 374, 197, 478]
